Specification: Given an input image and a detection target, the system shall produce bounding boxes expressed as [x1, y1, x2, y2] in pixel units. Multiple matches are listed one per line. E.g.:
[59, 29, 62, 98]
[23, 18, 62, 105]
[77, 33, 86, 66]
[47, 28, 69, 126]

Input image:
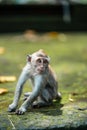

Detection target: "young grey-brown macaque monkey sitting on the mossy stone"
[8, 50, 61, 115]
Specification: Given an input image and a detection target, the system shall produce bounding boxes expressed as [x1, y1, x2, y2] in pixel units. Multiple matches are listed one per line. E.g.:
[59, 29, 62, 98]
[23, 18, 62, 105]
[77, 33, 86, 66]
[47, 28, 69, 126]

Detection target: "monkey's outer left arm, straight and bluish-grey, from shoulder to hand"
[8, 67, 29, 112]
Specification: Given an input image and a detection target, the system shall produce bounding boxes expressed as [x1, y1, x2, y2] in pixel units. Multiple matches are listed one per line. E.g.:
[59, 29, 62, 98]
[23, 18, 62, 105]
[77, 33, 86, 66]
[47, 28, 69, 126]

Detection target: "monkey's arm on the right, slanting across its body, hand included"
[17, 75, 45, 115]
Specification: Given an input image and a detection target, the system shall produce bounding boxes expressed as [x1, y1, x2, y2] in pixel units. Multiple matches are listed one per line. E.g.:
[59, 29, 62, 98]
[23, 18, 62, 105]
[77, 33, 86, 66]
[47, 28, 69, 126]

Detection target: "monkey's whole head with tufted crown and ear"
[27, 50, 50, 73]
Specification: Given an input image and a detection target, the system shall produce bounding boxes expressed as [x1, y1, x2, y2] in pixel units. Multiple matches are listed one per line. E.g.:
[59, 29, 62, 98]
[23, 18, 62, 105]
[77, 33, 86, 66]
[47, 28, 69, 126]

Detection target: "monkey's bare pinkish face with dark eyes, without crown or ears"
[32, 57, 49, 74]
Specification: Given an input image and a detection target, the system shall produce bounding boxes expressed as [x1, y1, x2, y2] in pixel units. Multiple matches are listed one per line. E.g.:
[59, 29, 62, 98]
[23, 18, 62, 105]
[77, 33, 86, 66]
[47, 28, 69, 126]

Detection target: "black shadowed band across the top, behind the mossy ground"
[0, 4, 87, 33]
